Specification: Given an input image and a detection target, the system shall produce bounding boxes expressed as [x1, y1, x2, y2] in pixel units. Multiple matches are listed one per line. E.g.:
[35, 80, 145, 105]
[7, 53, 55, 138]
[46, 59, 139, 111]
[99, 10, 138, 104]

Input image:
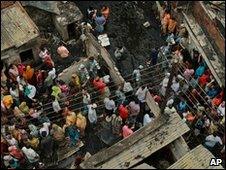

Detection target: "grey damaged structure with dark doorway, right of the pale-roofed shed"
[22, 1, 83, 42]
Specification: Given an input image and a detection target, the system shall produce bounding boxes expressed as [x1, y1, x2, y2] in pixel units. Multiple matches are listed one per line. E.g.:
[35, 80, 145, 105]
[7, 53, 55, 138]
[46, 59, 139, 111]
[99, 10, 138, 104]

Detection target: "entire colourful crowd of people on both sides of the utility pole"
[1, 1, 225, 169]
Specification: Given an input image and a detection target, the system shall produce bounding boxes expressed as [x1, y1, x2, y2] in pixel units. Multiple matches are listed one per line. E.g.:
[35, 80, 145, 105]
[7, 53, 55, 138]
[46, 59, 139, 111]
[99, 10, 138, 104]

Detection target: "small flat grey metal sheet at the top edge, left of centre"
[21, 1, 60, 15]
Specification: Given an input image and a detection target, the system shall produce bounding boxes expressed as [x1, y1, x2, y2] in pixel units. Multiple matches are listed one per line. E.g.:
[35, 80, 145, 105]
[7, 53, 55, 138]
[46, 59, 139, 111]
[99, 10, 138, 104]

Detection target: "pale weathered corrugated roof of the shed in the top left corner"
[1, 2, 39, 51]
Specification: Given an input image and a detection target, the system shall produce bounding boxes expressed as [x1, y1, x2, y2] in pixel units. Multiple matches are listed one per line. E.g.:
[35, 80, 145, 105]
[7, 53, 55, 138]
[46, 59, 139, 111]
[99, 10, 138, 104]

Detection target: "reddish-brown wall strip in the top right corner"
[191, 1, 225, 56]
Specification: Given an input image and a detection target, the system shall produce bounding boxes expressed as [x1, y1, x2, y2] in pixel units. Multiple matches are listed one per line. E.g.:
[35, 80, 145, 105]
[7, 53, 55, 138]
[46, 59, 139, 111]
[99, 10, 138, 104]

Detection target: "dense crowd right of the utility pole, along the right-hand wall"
[155, 2, 225, 162]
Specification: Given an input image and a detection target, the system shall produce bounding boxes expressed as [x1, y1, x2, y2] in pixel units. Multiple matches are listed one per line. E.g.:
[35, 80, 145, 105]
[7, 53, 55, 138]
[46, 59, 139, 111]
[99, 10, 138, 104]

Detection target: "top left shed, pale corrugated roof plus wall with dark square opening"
[1, 1, 39, 64]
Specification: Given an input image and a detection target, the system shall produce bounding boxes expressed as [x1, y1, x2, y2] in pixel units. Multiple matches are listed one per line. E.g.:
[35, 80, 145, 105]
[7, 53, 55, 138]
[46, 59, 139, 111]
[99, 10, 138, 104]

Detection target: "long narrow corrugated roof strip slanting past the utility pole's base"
[81, 113, 189, 169]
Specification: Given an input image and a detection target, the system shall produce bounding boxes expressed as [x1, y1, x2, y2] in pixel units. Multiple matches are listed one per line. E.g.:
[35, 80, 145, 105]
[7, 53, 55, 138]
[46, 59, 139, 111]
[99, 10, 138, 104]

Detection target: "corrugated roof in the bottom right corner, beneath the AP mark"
[168, 145, 223, 169]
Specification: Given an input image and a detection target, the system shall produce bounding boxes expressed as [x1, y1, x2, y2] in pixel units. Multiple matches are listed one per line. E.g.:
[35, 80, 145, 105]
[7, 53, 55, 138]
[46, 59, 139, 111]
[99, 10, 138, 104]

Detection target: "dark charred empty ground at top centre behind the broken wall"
[75, 1, 164, 76]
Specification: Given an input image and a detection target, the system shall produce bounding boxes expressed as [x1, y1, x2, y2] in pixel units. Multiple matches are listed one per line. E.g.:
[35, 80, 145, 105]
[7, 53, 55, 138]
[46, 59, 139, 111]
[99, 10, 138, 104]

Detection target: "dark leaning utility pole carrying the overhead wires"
[160, 59, 178, 114]
